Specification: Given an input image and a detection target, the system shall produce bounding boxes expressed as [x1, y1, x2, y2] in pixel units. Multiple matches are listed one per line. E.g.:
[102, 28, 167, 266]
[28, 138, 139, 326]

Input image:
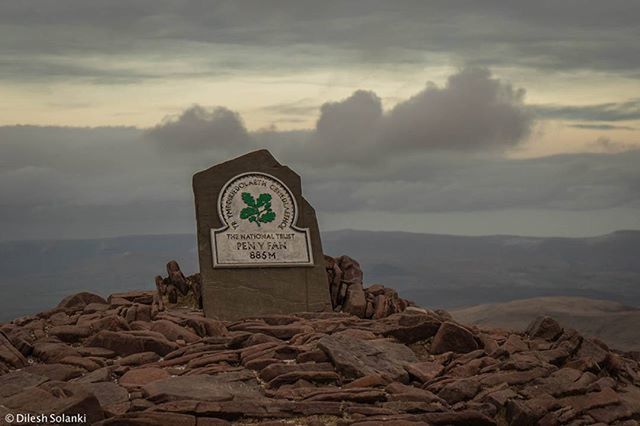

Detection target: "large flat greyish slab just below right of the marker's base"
[318, 335, 417, 382]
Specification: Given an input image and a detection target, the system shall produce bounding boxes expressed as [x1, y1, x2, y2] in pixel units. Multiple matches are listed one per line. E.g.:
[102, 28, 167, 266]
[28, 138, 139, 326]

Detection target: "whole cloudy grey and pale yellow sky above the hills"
[0, 0, 640, 240]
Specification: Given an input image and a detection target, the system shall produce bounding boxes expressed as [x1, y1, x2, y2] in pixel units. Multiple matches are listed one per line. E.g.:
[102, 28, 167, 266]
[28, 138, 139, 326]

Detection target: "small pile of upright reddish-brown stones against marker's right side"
[325, 256, 412, 319]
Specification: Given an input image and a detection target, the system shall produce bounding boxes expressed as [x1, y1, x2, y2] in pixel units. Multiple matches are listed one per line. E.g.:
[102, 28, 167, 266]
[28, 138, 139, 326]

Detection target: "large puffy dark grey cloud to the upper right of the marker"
[302, 69, 534, 162]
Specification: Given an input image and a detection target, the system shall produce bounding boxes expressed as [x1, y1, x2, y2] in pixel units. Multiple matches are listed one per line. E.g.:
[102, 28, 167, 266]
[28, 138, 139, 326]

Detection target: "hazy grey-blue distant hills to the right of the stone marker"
[323, 231, 640, 308]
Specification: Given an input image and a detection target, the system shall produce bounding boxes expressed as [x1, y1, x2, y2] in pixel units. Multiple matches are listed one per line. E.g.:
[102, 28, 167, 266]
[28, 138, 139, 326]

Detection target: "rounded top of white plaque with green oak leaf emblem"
[218, 172, 296, 231]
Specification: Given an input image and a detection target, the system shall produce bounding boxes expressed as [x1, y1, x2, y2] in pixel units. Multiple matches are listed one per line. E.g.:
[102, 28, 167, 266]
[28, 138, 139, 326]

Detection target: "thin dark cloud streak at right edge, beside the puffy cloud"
[532, 99, 640, 121]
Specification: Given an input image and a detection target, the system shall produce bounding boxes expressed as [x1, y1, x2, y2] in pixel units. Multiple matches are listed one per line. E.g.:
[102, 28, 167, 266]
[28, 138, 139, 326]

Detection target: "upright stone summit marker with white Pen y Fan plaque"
[193, 150, 331, 320]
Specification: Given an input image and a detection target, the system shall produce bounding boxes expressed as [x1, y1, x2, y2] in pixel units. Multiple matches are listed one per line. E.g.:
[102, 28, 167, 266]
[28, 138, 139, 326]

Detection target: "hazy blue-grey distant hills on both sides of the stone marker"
[0, 231, 640, 321]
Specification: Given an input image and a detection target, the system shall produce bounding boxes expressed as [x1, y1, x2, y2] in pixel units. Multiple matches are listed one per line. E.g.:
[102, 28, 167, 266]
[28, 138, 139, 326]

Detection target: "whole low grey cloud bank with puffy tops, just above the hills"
[0, 69, 640, 239]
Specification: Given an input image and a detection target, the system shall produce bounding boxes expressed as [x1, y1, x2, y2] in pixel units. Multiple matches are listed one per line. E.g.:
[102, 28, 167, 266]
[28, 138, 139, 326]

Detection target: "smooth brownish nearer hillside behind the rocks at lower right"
[450, 297, 640, 351]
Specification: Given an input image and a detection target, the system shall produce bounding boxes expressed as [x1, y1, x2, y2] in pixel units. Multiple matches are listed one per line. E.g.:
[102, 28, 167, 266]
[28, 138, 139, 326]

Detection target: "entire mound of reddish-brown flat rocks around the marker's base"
[0, 257, 640, 426]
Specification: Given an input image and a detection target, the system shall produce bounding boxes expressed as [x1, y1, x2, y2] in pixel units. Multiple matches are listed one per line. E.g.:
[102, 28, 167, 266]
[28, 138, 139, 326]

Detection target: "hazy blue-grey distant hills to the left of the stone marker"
[0, 235, 197, 321]
